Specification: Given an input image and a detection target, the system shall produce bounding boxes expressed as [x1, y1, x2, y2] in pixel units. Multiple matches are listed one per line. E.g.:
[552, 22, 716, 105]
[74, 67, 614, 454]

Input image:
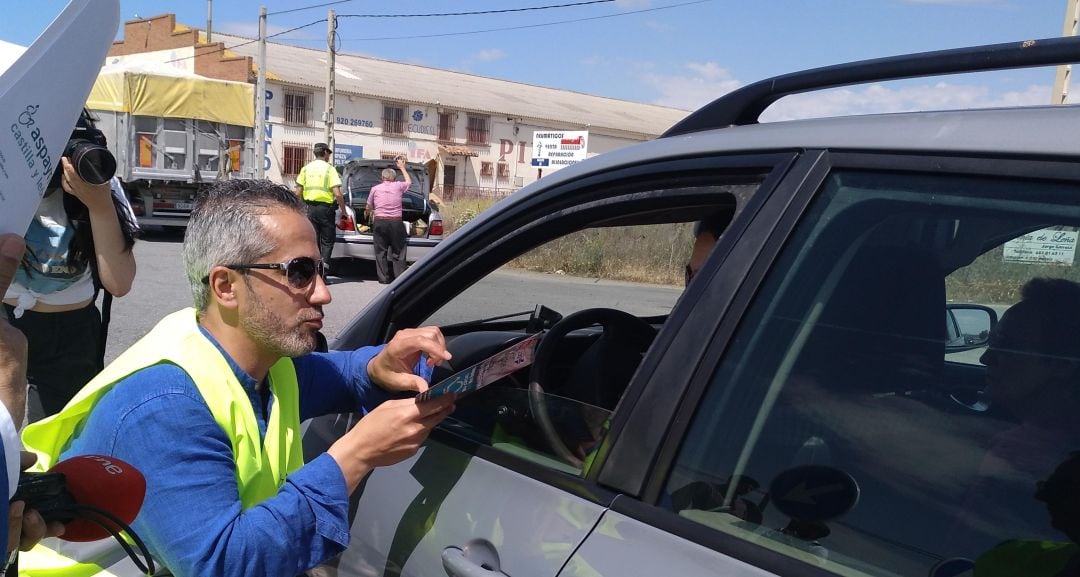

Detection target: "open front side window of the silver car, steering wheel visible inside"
[422, 183, 758, 474]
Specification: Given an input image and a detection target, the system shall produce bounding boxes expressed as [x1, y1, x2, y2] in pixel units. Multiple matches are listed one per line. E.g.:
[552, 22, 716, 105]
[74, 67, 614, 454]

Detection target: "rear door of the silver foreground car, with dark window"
[559, 152, 1080, 577]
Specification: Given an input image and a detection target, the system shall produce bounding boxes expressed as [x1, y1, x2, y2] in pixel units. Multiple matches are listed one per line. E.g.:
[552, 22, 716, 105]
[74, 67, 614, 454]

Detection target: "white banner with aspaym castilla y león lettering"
[0, 0, 120, 234]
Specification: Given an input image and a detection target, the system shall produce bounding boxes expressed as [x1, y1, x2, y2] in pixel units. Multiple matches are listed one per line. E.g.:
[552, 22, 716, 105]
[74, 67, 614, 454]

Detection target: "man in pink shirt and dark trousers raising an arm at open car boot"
[367, 157, 413, 284]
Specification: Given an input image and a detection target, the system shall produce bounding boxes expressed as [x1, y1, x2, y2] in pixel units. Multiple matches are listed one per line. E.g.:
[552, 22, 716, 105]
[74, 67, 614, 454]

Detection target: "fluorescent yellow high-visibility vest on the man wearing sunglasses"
[19, 308, 303, 577]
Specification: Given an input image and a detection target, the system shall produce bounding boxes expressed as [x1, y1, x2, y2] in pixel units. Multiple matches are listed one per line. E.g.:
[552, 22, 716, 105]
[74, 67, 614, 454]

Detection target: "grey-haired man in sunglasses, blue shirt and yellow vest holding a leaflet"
[21, 180, 453, 577]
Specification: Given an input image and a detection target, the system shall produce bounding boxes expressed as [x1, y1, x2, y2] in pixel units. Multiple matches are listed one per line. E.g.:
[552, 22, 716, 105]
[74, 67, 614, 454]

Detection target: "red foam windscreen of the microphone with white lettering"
[49, 455, 146, 541]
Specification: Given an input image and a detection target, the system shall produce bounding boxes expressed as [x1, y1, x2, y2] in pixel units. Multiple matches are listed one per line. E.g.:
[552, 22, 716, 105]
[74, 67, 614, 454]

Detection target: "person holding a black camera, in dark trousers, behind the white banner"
[3, 110, 138, 421]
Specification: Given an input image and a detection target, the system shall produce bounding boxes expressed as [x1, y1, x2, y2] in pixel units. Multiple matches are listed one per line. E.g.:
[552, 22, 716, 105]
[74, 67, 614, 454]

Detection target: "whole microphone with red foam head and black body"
[12, 455, 153, 573]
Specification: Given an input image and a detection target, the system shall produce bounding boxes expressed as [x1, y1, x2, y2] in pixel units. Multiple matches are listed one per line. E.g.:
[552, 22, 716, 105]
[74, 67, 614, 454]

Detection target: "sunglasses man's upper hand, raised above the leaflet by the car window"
[367, 326, 450, 395]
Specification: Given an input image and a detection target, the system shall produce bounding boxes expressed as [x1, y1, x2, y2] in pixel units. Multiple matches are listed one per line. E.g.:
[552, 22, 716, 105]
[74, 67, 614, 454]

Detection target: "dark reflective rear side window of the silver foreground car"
[661, 171, 1080, 577]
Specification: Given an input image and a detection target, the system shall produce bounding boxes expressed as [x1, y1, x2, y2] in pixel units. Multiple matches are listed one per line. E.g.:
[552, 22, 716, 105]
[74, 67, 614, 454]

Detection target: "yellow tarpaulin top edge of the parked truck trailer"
[86, 71, 255, 126]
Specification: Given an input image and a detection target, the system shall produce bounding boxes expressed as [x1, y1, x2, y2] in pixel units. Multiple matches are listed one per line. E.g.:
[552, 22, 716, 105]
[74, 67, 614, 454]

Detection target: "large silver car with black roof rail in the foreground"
[305, 38, 1080, 577]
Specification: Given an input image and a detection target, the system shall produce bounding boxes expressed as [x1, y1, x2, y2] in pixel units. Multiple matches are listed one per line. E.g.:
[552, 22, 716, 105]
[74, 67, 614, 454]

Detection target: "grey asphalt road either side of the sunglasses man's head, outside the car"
[105, 230, 383, 363]
